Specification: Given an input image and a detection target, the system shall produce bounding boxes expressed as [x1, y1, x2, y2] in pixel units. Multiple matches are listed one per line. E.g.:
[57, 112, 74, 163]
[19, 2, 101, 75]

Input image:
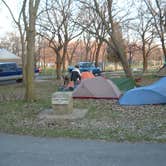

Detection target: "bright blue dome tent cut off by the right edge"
[119, 77, 166, 105]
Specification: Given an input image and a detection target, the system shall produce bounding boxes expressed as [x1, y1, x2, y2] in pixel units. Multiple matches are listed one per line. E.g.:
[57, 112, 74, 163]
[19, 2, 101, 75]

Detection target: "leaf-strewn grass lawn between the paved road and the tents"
[0, 76, 166, 142]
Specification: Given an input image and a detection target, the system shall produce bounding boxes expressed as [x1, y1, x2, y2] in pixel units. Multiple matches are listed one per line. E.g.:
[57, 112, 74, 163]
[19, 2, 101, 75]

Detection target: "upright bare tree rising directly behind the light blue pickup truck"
[77, 1, 106, 66]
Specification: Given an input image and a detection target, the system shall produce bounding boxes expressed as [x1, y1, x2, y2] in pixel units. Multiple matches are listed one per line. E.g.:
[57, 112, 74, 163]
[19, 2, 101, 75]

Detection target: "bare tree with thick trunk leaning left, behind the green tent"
[81, 0, 132, 77]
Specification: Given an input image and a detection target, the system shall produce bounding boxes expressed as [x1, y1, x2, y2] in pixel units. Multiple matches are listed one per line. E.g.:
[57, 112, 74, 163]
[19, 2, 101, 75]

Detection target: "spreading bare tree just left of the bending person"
[40, 0, 81, 79]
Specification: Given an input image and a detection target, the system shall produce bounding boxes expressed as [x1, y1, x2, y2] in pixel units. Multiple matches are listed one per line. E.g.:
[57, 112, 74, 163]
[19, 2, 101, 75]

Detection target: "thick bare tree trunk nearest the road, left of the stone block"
[2, 0, 40, 101]
